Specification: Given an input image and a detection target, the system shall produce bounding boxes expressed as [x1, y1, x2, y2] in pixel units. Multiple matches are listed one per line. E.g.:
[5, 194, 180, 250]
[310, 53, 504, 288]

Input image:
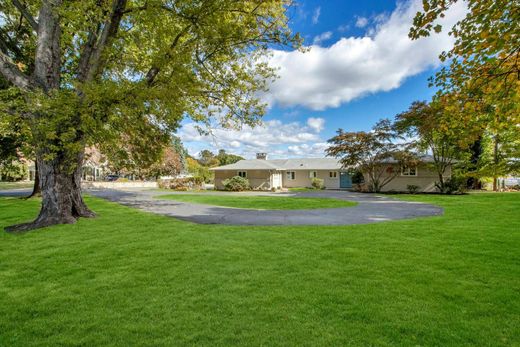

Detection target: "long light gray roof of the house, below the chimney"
[210, 158, 341, 171]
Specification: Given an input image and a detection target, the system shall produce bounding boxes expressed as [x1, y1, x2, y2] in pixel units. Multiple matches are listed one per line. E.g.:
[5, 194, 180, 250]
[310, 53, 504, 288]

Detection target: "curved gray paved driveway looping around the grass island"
[87, 189, 443, 225]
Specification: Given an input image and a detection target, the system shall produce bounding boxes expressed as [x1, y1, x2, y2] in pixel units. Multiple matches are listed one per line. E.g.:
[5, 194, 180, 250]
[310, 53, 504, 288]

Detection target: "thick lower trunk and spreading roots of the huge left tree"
[6, 152, 95, 232]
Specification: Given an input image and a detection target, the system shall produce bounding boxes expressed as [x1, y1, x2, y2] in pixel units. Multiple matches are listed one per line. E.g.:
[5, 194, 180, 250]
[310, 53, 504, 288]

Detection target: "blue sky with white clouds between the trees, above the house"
[177, 0, 465, 159]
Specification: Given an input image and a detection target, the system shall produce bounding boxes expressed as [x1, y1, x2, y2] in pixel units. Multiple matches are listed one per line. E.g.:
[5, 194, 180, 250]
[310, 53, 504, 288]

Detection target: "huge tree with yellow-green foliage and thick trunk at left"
[0, 0, 300, 231]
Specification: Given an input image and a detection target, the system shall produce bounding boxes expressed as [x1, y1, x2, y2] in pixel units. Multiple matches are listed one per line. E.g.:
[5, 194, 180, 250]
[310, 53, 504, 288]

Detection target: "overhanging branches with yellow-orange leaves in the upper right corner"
[410, 0, 520, 103]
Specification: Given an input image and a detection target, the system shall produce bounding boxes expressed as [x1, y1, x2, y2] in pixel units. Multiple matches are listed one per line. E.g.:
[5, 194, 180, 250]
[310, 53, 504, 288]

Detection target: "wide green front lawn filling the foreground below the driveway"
[0, 194, 520, 346]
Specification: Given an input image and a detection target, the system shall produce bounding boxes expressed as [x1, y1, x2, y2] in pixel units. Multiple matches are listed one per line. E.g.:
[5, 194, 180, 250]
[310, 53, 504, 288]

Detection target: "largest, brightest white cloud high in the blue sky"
[266, 0, 466, 110]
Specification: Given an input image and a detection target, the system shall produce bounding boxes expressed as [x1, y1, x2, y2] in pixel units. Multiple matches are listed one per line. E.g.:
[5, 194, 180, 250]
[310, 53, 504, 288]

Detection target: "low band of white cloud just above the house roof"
[178, 117, 325, 158]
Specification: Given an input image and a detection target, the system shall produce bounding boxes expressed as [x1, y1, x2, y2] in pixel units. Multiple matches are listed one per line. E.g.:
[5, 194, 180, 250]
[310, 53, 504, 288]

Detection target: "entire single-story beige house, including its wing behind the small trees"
[210, 153, 451, 192]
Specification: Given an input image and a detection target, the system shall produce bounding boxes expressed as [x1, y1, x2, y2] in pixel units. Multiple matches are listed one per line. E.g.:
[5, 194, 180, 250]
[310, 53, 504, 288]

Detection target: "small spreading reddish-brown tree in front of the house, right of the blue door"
[327, 119, 414, 192]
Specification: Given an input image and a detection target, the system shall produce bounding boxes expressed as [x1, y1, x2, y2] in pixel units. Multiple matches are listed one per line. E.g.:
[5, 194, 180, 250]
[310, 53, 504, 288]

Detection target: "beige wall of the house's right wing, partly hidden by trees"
[365, 165, 451, 192]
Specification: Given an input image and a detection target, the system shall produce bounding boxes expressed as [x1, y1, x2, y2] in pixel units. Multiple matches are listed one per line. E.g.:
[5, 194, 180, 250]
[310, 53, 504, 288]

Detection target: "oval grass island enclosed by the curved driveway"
[158, 194, 357, 210]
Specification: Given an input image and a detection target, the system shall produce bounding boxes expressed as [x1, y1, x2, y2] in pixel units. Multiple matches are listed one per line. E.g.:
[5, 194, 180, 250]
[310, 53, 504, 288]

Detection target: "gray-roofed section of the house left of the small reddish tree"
[210, 153, 352, 190]
